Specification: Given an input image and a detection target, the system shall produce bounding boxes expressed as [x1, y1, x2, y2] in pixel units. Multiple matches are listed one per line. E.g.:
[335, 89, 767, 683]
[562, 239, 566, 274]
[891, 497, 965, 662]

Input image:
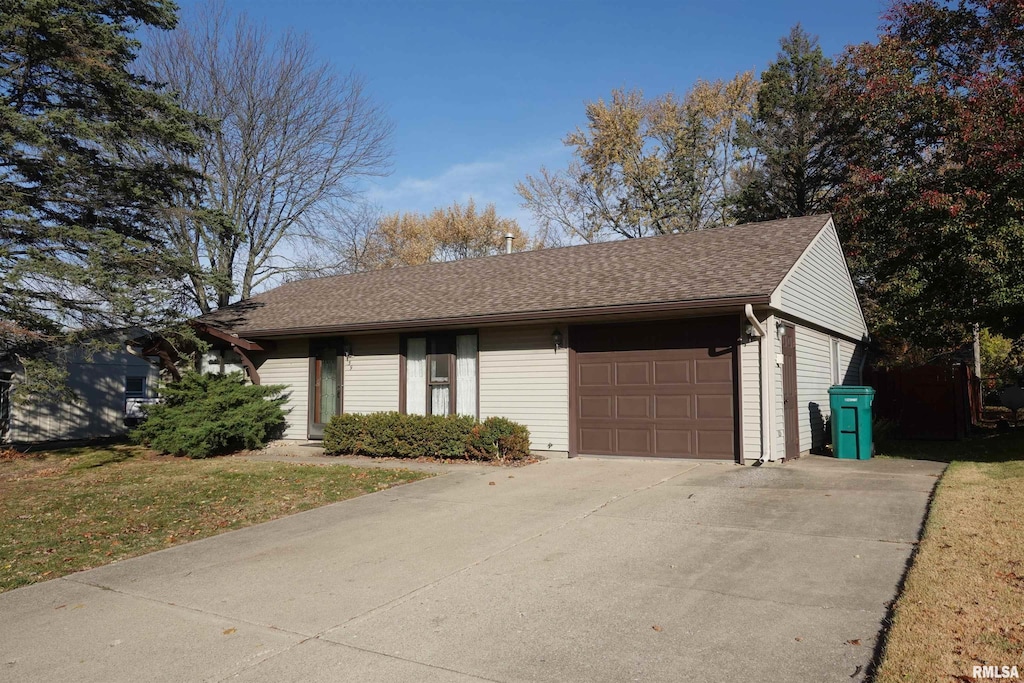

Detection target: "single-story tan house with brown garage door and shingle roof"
[197, 215, 867, 463]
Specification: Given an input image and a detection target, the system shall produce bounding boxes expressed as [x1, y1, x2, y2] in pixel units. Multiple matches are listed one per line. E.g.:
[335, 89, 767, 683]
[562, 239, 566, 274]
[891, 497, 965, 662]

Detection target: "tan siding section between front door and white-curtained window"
[343, 334, 399, 413]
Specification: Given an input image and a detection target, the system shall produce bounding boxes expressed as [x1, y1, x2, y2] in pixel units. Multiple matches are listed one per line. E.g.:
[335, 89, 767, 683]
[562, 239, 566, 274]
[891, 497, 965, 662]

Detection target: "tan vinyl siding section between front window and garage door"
[479, 325, 569, 451]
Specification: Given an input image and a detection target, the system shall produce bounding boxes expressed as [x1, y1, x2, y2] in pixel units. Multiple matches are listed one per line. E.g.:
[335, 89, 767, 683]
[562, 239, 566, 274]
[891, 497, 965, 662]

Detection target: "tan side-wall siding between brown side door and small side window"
[797, 326, 833, 453]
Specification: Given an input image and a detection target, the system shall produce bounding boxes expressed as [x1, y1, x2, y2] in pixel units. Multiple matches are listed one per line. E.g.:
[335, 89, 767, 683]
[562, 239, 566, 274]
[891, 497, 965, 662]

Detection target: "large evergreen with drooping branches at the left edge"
[0, 0, 202, 355]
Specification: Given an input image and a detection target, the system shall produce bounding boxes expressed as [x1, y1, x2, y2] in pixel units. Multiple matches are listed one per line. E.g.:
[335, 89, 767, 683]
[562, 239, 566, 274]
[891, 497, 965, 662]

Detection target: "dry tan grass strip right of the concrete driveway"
[876, 428, 1024, 683]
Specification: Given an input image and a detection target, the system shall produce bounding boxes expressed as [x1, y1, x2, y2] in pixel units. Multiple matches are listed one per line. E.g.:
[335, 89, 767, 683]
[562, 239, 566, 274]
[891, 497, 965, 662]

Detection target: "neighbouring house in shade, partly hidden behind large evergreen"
[0, 329, 165, 443]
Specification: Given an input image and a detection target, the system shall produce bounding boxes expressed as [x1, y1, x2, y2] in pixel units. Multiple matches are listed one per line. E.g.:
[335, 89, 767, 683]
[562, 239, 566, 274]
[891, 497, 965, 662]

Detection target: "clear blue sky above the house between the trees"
[181, 0, 887, 228]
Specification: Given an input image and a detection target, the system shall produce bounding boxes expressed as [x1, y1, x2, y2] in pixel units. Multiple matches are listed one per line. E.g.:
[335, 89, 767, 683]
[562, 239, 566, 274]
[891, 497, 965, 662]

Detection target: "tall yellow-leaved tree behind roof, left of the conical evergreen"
[516, 73, 758, 242]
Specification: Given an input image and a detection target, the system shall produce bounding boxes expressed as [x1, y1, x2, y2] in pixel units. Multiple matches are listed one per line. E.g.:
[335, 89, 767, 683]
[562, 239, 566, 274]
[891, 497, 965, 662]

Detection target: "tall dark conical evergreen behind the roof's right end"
[734, 24, 844, 222]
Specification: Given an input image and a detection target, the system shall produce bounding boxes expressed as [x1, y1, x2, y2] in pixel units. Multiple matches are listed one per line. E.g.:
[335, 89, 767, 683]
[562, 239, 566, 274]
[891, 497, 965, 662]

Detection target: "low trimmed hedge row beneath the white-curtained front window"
[324, 413, 529, 461]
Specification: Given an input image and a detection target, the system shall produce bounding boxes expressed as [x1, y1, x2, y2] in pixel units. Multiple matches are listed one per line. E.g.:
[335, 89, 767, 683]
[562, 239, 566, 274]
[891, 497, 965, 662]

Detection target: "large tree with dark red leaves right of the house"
[833, 0, 1024, 361]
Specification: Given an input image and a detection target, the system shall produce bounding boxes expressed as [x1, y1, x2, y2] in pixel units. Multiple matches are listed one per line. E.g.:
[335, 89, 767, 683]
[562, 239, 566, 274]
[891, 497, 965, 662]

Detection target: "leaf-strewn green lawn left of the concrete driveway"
[0, 445, 429, 592]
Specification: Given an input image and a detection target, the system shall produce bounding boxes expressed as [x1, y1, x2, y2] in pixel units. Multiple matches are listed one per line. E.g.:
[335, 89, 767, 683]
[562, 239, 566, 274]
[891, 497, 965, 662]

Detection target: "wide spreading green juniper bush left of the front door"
[131, 373, 288, 458]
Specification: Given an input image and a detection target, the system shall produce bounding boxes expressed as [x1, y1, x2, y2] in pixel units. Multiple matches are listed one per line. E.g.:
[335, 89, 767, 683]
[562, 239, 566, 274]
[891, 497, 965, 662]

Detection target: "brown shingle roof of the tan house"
[200, 215, 828, 337]
